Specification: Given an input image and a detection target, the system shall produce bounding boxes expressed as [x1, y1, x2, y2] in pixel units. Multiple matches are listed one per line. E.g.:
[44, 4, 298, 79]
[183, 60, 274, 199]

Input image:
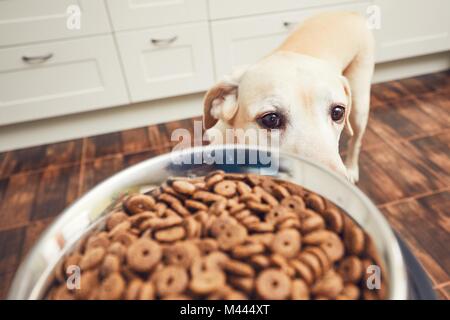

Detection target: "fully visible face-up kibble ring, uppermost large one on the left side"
[127, 238, 162, 272]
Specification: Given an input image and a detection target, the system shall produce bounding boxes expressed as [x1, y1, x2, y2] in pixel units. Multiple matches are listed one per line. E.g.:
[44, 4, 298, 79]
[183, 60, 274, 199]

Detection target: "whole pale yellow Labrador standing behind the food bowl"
[203, 12, 374, 183]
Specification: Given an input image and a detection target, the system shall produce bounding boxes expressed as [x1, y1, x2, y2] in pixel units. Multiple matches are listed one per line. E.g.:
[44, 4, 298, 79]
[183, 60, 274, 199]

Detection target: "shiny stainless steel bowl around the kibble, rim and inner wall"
[8, 145, 407, 299]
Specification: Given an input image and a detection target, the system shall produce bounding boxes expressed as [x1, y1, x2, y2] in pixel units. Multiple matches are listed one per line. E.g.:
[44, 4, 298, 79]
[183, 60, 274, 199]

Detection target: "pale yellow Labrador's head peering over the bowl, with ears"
[203, 52, 352, 175]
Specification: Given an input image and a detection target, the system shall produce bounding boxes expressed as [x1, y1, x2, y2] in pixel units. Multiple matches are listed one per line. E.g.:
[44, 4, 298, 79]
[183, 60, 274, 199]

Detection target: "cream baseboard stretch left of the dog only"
[0, 93, 204, 152]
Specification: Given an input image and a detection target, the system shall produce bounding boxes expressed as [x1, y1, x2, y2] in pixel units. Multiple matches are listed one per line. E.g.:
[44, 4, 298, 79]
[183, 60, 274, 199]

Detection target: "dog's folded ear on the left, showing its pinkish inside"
[203, 67, 246, 130]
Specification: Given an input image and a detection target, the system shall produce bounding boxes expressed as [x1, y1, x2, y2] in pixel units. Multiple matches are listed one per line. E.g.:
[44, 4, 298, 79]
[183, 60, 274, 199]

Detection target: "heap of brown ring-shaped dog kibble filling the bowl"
[47, 171, 386, 300]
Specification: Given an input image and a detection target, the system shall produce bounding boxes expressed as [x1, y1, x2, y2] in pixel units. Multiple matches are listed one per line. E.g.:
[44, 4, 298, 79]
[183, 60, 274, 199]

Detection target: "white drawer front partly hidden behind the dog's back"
[211, 3, 368, 79]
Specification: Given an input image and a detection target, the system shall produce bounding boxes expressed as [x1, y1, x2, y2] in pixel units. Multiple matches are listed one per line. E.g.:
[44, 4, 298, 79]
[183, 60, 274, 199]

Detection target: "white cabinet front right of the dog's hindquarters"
[375, 0, 450, 62]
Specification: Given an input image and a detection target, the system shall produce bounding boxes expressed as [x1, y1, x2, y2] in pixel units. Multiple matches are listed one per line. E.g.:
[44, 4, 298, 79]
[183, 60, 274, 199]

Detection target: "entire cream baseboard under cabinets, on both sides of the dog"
[0, 51, 450, 152]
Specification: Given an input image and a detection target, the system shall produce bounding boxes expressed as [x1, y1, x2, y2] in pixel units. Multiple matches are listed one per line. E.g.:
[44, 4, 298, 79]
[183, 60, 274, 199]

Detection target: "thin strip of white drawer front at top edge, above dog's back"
[209, 0, 357, 19]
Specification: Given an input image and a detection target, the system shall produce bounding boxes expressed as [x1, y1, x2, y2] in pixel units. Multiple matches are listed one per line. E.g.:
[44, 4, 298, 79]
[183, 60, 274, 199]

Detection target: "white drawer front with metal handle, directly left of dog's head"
[117, 23, 213, 102]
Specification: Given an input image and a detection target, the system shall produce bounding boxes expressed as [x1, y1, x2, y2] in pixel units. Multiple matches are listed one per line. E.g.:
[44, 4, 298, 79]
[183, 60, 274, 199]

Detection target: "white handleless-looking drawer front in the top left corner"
[0, 0, 110, 46]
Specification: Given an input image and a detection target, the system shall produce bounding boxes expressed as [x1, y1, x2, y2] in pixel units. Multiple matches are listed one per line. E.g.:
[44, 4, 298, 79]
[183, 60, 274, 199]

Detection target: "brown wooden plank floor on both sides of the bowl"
[0, 71, 450, 299]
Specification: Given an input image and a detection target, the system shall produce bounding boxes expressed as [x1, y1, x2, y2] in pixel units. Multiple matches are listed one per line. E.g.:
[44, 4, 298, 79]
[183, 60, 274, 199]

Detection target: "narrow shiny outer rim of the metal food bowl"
[7, 144, 408, 300]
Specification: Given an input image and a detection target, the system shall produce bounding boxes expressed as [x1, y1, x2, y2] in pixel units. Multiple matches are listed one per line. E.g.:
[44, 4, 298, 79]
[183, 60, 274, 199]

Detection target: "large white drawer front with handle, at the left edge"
[0, 36, 129, 125]
